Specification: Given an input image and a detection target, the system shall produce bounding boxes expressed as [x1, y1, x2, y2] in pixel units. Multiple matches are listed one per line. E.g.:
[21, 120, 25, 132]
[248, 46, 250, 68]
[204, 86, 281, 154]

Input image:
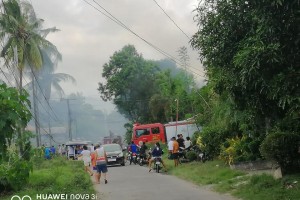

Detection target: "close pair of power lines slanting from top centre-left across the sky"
[83, 0, 205, 78]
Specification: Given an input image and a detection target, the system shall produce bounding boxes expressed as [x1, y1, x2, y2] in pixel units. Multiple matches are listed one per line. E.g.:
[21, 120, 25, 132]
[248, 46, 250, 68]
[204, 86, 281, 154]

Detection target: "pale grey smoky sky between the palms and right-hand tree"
[30, 0, 201, 106]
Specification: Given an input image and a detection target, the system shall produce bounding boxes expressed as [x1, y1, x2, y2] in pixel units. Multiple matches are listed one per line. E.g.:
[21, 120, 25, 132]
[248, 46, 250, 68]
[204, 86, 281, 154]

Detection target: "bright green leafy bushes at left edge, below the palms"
[0, 84, 32, 193]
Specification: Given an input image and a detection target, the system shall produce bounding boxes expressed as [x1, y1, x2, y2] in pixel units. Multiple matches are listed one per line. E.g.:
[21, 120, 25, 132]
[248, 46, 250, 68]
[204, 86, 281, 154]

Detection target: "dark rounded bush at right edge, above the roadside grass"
[260, 130, 300, 173]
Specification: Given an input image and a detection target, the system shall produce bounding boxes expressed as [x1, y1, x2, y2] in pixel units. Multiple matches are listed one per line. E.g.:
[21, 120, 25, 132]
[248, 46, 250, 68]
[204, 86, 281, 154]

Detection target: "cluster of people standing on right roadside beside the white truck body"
[168, 134, 192, 167]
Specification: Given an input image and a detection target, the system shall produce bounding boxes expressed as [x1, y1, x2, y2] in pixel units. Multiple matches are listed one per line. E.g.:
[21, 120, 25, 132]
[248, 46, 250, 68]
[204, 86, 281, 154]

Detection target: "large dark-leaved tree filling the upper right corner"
[191, 0, 300, 136]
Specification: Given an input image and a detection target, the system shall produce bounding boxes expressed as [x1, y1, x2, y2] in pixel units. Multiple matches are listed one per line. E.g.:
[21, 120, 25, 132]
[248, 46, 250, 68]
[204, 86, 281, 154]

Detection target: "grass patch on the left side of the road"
[1, 157, 96, 200]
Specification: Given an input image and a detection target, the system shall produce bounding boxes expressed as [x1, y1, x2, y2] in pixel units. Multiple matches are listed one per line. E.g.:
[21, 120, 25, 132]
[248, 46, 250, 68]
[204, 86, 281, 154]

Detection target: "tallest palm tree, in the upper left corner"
[0, 0, 56, 150]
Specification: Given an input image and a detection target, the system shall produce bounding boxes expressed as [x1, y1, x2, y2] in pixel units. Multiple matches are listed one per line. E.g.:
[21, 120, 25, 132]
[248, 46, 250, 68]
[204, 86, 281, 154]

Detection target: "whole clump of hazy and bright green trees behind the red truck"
[98, 45, 199, 123]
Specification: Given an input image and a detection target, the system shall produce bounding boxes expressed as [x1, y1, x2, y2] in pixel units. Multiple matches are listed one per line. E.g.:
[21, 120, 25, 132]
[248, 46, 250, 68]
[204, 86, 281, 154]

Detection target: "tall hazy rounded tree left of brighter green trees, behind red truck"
[98, 45, 158, 123]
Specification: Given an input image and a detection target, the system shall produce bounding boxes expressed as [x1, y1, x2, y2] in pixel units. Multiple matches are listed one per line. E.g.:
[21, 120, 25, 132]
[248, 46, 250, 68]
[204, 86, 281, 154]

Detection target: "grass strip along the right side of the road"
[164, 155, 300, 200]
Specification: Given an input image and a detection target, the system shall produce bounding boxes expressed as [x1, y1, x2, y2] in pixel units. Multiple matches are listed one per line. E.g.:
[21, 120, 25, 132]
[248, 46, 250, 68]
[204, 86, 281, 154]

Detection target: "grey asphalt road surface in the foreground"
[95, 163, 234, 200]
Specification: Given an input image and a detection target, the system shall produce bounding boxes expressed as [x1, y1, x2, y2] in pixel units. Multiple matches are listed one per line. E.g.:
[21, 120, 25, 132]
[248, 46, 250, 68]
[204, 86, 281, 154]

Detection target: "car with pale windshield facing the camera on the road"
[103, 144, 125, 166]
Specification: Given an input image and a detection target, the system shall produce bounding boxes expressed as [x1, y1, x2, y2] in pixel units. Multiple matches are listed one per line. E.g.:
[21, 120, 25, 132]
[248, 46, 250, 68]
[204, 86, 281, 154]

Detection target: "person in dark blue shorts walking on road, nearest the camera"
[95, 144, 107, 184]
